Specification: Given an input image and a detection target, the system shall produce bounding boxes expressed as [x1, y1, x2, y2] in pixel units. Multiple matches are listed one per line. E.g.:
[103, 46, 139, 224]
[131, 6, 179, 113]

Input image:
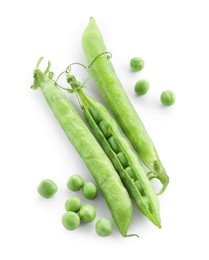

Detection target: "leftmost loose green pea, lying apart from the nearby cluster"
[37, 179, 57, 199]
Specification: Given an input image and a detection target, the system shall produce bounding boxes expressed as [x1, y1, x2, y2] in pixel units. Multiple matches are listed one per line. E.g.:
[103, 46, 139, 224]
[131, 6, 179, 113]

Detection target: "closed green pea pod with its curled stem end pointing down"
[82, 17, 169, 194]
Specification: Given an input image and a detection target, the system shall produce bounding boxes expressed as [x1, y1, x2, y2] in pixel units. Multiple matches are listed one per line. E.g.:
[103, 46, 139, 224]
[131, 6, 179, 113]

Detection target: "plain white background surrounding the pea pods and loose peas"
[0, 0, 209, 260]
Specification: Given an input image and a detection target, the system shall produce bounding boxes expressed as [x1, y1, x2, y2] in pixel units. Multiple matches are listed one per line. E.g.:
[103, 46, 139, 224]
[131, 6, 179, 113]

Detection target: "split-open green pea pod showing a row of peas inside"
[67, 75, 160, 227]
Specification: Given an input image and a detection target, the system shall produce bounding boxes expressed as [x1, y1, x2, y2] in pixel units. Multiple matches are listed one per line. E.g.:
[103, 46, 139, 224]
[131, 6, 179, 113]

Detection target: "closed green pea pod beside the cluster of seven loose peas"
[32, 60, 133, 236]
